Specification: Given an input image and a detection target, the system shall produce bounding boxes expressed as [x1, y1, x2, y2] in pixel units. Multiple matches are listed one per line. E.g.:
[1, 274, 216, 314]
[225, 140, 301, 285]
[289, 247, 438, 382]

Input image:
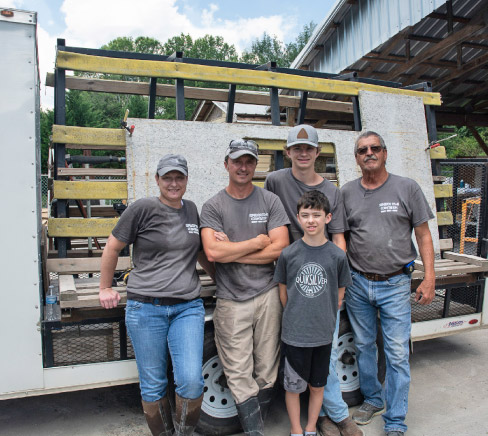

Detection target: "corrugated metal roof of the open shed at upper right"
[292, 0, 488, 126]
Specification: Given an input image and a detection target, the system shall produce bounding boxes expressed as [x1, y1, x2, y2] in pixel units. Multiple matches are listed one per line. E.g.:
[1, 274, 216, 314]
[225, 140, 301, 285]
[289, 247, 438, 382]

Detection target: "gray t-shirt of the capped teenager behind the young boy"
[264, 168, 347, 242]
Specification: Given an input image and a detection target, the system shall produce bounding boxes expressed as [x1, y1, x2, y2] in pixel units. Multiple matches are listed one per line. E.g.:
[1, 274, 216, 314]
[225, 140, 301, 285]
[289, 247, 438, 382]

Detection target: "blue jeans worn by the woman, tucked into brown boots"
[125, 299, 205, 401]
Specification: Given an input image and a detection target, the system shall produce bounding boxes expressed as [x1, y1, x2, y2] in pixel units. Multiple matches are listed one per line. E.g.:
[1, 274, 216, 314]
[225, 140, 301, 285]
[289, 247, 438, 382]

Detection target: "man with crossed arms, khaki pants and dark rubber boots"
[200, 140, 289, 436]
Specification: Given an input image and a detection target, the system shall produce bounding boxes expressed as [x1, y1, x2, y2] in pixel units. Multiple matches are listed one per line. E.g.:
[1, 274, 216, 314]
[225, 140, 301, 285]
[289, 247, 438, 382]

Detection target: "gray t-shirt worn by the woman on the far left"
[112, 197, 201, 300]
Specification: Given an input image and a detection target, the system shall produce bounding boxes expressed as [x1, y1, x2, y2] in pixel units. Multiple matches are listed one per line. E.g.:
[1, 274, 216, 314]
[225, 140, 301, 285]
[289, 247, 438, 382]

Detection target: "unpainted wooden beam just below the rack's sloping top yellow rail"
[46, 73, 353, 113]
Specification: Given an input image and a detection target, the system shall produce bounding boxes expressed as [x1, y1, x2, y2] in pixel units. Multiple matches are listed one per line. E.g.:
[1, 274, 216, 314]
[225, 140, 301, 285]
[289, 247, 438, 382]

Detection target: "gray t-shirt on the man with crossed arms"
[200, 186, 289, 301]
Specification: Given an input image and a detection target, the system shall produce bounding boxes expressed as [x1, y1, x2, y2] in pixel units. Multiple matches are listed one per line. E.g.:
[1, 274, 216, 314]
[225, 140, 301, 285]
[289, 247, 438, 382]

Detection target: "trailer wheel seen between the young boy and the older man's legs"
[336, 310, 386, 407]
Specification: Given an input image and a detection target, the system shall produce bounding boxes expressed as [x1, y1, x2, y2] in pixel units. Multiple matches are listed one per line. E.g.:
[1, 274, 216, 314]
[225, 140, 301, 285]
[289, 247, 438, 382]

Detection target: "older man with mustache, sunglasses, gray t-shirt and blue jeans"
[342, 131, 435, 436]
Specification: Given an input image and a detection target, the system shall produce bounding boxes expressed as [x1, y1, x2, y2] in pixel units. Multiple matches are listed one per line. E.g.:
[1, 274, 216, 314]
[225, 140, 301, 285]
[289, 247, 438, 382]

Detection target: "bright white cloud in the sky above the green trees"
[25, 0, 297, 108]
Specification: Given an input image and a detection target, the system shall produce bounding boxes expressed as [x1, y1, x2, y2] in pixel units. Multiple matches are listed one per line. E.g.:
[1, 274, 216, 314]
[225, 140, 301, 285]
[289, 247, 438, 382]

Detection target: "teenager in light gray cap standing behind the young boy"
[264, 124, 363, 436]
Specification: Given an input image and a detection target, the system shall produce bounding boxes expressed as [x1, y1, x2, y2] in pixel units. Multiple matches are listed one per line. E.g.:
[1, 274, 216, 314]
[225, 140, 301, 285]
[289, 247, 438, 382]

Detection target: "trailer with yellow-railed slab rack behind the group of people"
[0, 8, 488, 434]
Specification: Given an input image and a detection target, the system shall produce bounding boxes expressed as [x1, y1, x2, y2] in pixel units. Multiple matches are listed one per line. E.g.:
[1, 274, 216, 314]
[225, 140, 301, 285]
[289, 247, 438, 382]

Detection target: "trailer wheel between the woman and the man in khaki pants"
[197, 326, 242, 436]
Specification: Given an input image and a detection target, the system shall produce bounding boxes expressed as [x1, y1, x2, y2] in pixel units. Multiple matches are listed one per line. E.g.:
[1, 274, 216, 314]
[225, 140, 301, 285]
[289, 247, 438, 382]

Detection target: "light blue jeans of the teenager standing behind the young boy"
[320, 311, 349, 422]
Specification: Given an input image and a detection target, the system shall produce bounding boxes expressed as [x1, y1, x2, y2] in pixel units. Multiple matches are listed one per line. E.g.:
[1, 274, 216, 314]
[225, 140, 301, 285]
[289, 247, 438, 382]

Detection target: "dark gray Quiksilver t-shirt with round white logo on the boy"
[274, 239, 352, 347]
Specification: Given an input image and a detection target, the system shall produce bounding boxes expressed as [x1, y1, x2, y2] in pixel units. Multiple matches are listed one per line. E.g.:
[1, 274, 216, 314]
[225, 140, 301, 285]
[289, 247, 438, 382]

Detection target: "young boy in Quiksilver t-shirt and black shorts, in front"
[274, 190, 351, 436]
